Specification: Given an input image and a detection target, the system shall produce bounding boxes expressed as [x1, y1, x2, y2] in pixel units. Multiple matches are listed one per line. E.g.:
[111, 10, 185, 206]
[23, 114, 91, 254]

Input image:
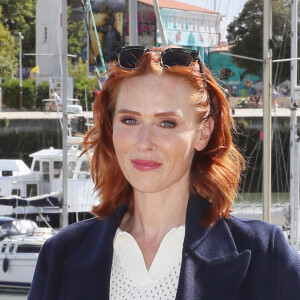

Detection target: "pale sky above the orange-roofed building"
[177, 0, 247, 41]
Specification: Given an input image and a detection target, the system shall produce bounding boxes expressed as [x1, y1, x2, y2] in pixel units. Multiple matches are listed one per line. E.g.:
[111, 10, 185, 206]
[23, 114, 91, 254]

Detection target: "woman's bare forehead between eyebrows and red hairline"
[116, 74, 196, 109]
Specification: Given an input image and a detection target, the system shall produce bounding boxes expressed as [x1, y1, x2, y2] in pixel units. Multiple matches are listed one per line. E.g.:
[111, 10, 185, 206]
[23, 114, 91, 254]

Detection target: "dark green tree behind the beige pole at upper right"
[227, 0, 290, 82]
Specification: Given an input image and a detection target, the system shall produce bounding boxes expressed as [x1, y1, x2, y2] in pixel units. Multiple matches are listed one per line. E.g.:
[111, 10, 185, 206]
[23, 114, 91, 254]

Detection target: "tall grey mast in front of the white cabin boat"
[61, 0, 69, 228]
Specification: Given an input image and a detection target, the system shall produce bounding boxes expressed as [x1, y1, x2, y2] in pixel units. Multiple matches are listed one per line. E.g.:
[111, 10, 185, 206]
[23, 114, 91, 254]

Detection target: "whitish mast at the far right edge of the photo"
[290, 0, 300, 250]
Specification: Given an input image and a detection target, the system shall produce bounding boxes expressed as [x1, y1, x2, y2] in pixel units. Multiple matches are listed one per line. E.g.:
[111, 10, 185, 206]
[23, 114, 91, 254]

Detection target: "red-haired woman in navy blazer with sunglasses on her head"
[29, 47, 300, 300]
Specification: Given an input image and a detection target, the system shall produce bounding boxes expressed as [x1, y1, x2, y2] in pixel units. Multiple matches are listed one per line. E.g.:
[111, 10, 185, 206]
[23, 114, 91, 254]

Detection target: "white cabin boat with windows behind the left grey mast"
[0, 137, 98, 228]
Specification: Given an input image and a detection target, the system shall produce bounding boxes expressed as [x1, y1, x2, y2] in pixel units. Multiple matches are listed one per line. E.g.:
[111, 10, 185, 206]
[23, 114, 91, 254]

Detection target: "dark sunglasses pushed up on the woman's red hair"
[116, 46, 207, 88]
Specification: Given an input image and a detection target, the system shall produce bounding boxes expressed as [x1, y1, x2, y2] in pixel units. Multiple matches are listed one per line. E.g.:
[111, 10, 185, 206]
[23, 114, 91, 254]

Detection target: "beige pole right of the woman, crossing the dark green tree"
[263, 0, 272, 222]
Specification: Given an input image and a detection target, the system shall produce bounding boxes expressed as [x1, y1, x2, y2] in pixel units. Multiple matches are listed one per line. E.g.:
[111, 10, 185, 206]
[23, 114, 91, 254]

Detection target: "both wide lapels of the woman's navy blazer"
[64, 195, 250, 300]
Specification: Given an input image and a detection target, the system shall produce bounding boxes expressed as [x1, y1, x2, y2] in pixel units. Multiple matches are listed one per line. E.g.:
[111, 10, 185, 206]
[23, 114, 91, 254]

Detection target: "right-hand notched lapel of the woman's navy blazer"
[176, 196, 251, 300]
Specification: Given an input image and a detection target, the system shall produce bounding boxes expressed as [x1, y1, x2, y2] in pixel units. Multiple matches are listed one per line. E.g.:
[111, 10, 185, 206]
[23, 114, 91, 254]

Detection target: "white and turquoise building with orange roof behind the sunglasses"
[138, 0, 223, 61]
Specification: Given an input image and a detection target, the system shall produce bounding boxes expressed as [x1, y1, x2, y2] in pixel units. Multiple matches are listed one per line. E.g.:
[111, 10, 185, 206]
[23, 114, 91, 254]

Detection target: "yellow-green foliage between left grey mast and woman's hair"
[68, 58, 97, 110]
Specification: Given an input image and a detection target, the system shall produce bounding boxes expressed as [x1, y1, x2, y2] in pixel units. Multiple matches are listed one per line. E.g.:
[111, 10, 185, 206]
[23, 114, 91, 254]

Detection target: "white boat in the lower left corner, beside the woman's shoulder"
[0, 217, 55, 291]
